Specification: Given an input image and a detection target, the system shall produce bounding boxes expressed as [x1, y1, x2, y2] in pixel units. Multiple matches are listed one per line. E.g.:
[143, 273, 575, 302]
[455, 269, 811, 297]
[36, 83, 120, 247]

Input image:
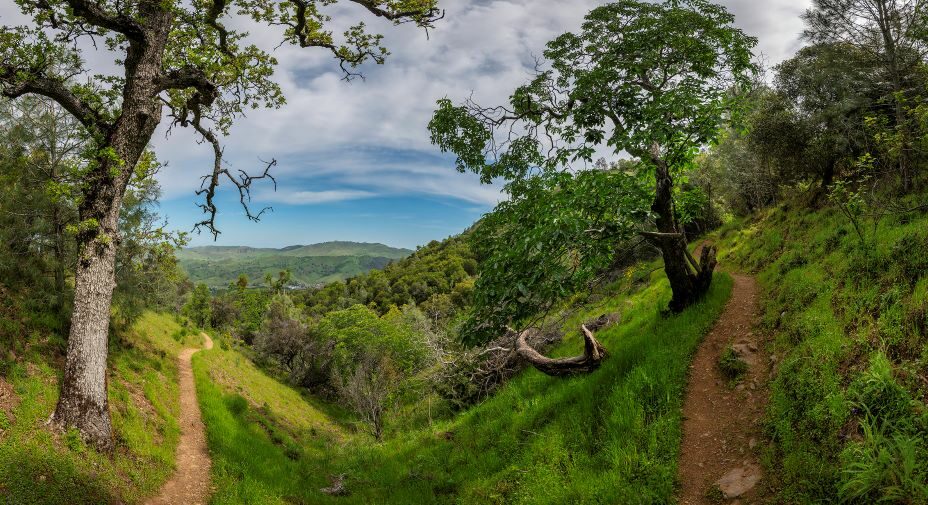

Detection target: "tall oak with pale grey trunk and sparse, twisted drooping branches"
[0, 0, 443, 449]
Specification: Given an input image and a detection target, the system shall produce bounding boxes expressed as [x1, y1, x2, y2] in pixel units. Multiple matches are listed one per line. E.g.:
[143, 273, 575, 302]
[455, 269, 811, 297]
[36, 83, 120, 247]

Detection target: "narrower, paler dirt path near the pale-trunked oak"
[146, 333, 213, 505]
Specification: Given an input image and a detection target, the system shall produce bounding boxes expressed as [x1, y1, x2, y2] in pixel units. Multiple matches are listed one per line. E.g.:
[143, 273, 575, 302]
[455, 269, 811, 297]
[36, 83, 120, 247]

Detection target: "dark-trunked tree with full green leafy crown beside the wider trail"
[429, 0, 756, 341]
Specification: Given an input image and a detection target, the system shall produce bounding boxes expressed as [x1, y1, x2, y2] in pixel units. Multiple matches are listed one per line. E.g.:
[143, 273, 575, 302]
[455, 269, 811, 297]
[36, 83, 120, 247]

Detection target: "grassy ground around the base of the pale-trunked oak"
[0, 313, 198, 505]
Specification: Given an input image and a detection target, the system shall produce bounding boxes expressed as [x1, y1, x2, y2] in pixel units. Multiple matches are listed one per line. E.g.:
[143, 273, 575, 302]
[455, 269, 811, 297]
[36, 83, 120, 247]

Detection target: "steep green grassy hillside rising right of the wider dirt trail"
[720, 200, 928, 503]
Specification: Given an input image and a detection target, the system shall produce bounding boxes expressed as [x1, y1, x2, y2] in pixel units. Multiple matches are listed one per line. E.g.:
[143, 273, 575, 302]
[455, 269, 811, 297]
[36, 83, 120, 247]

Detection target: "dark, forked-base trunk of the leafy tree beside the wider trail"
[645, 146, 716, 313]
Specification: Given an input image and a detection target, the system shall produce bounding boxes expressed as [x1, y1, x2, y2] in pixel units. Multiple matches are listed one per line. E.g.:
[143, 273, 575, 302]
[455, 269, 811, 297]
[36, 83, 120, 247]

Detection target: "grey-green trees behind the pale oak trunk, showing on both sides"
[0, 95, 183, 353]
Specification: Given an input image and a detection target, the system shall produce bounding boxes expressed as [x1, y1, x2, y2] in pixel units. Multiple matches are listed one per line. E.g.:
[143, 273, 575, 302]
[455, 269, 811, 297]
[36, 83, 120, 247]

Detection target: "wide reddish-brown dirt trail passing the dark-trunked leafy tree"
[678, 275, 771, 505]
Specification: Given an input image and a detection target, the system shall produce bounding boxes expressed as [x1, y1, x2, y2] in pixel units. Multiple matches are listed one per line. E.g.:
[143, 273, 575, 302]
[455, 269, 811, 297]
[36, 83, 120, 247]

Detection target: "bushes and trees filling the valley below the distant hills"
[196, 237, 477, 437]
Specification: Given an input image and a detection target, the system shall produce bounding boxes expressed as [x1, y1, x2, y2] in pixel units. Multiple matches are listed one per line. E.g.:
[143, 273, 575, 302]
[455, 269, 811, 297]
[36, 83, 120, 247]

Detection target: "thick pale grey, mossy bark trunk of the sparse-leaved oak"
[53, 6, 173, 450]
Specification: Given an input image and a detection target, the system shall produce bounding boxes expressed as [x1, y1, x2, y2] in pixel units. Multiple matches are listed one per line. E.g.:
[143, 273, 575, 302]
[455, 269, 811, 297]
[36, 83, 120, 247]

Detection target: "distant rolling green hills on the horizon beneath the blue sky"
[177, 242, 412, 288]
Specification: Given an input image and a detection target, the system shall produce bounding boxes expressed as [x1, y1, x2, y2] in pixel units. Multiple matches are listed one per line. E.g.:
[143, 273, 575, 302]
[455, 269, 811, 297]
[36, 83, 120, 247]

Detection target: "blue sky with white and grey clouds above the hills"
[0, 0, 811, 247]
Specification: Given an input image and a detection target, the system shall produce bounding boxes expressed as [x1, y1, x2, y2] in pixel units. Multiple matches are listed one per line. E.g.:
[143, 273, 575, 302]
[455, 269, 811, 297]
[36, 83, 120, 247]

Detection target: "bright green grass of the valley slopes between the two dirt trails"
[194, 262, 732, 504]
